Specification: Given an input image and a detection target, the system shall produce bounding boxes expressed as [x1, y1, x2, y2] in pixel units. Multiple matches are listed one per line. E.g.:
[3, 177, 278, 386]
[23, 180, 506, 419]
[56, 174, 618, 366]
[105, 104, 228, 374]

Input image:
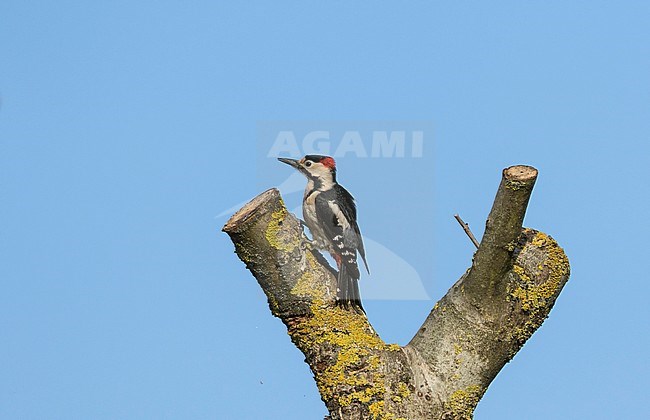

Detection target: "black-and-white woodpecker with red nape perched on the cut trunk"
[278, 155, 370, 312]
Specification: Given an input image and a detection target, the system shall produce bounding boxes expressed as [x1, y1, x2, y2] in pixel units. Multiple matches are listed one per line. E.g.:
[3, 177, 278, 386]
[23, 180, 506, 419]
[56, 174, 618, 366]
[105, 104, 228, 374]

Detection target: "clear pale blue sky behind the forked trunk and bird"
[0, 0, 650, 420]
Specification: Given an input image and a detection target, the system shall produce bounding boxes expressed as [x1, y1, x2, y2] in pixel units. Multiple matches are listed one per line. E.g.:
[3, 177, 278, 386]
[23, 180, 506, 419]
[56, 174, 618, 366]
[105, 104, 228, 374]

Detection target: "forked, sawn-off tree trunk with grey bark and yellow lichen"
[223, 166, 569, 420]
